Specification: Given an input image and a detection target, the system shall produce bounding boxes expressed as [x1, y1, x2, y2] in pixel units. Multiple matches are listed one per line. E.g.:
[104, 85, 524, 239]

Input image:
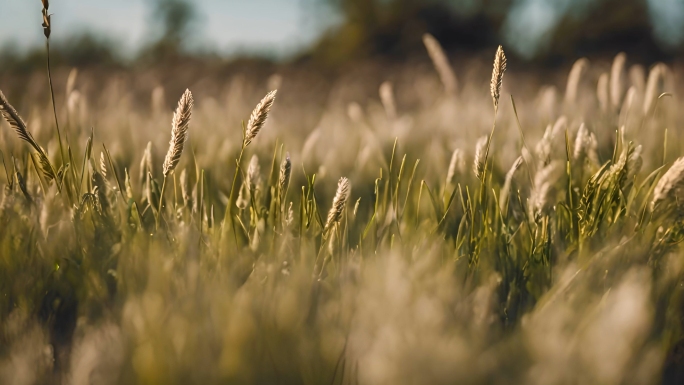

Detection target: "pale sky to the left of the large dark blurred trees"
[0, 0, 328, 55]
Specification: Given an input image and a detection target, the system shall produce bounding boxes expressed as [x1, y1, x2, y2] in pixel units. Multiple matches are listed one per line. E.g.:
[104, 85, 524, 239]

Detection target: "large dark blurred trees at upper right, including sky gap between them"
[309, 0, 684, 63]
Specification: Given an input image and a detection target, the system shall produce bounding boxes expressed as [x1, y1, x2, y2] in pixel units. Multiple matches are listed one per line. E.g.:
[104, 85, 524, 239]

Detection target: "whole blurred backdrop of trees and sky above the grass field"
[0, 0, 684, 72]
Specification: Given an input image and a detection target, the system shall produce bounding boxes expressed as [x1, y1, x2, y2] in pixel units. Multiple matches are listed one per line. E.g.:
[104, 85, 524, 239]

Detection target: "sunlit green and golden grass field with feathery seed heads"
[0, 26, 684, 384]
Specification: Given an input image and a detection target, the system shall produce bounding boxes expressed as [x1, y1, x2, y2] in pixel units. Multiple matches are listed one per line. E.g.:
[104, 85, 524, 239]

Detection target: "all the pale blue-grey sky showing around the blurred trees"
[0, 0, 684, 57]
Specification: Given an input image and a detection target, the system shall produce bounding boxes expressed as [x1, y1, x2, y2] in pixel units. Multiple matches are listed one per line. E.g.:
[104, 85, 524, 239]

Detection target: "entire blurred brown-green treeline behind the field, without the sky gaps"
[0, 0, 684, 72]
